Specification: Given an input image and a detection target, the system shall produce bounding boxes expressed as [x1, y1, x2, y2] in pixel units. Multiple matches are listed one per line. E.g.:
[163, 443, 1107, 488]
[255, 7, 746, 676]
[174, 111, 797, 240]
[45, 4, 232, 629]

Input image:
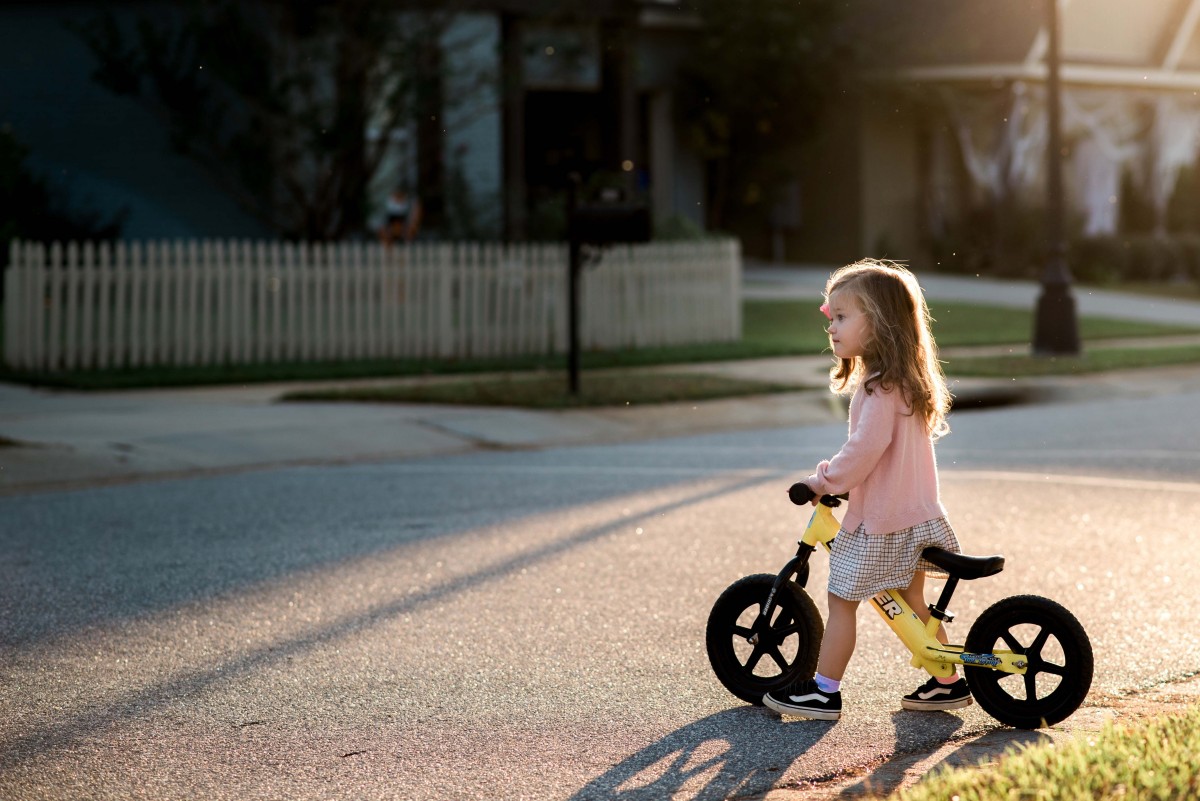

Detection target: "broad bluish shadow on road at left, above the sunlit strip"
[0, 454, 787, 648]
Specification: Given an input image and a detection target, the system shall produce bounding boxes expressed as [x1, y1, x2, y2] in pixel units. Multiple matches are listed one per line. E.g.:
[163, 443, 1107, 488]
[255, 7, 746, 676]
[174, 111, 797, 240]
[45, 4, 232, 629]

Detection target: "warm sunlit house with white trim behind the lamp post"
[806, 0, 1200, 271]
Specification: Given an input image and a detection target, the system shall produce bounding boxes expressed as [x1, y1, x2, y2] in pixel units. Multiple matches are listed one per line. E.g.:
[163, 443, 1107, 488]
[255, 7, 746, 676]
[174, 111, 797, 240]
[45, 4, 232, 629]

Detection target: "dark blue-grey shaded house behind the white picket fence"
[0, 0, 704, 245]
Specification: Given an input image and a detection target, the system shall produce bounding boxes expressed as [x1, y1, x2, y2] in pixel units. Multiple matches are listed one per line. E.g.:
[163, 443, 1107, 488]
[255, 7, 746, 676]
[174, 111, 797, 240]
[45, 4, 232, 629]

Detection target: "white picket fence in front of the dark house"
[4, 240, 742, 372]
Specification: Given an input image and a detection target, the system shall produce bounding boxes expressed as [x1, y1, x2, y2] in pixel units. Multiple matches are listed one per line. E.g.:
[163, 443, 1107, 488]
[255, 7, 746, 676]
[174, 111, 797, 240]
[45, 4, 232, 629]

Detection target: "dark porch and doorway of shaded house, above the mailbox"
[504, 0, 706, 239]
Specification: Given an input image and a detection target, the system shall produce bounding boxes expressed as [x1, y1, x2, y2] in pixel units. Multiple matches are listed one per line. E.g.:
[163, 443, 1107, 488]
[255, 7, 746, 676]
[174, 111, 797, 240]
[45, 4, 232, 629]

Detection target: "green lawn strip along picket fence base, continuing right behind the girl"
[7, 297, 1200, 390]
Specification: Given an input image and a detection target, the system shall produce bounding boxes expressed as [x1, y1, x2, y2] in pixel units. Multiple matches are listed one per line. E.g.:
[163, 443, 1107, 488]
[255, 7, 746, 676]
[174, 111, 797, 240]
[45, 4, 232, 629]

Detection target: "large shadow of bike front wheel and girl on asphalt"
[569, 706, 834, 801]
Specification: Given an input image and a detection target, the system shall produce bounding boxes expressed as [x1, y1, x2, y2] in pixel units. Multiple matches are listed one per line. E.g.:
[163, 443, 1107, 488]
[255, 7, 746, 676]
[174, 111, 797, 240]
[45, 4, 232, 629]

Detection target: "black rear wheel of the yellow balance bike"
[966, 595, 1093, 729]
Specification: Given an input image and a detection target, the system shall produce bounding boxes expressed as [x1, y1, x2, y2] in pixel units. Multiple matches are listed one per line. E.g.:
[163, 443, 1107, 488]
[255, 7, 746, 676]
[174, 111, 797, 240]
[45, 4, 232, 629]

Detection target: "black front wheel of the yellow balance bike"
[704, 573, 824, 705]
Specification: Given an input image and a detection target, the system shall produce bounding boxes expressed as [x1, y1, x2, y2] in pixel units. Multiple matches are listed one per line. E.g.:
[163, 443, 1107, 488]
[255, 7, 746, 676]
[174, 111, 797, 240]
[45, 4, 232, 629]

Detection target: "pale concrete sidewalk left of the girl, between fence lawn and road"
[0, 359, 838, 495]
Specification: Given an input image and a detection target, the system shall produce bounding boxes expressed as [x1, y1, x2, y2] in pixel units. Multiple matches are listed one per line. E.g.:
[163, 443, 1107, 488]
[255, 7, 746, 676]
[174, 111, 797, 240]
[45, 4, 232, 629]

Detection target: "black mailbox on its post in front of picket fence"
[566, 175, 650, 395]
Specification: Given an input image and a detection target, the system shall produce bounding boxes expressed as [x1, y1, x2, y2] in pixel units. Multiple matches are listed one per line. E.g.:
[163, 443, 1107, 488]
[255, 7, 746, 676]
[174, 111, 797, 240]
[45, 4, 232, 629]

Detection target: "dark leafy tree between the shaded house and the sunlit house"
[680, 0, 848, 241]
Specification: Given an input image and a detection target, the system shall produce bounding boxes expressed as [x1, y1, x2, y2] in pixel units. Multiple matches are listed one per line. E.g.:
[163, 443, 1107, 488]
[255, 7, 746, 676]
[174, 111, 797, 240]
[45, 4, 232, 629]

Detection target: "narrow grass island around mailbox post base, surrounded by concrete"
[284, 372, 797, 409]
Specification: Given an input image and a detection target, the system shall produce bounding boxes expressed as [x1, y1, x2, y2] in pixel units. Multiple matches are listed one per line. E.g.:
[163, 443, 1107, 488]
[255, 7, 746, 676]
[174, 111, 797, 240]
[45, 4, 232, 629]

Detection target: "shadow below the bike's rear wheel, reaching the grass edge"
[829, 711, 1046, 799]
